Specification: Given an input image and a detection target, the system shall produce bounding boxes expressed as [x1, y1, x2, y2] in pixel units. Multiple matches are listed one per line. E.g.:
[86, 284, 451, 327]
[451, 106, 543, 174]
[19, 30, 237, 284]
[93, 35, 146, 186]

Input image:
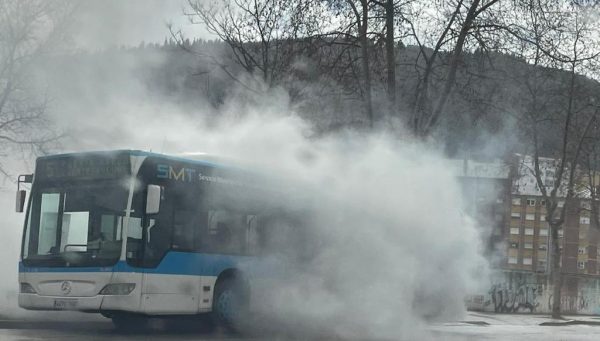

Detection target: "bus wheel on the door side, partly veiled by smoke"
[212, 279, 248, 332]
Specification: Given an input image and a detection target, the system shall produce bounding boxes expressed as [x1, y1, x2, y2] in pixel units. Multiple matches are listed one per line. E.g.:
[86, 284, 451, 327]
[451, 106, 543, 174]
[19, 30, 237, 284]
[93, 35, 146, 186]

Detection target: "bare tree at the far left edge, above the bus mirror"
[0, 0, 69, 175]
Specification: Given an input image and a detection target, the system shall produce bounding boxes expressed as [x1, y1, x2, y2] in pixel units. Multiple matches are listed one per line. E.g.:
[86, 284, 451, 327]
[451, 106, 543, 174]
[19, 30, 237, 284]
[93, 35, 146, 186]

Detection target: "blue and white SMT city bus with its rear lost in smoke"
[17, 150, 301, 328]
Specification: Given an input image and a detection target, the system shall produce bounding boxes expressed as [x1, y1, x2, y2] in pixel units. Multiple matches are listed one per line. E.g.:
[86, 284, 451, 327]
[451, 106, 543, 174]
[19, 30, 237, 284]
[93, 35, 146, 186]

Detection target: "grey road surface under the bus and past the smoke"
[0, 313, 600, 341]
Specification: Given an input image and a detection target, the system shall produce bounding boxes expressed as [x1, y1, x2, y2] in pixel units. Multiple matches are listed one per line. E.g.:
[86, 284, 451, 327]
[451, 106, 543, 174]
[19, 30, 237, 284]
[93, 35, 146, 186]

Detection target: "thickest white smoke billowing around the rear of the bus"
[165, 95, 487, 338]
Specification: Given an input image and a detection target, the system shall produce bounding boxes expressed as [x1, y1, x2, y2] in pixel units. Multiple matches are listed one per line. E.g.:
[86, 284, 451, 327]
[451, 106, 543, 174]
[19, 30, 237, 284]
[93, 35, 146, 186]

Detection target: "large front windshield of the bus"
[23, 180, 130, 266]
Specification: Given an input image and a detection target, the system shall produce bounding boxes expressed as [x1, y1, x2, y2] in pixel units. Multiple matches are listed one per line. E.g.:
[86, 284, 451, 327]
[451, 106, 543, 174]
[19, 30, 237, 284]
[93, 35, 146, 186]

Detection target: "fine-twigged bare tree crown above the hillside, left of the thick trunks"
[184, 0, 320, 86]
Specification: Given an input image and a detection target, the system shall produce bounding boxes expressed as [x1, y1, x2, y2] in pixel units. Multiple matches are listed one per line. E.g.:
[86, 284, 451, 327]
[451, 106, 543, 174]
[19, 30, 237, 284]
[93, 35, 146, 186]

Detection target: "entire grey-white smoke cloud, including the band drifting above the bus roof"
[2, 5, 487, 339]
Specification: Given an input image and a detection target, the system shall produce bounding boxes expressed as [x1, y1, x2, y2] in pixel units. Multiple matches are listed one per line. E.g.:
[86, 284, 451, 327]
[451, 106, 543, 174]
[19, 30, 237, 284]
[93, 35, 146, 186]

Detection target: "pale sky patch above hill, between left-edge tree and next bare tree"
[72, 0, 211, 50]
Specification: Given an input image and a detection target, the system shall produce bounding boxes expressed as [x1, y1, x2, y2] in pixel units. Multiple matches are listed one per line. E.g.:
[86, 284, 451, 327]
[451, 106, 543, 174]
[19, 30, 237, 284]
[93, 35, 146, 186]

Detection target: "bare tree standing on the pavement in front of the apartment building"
[504, 0, 600, 318]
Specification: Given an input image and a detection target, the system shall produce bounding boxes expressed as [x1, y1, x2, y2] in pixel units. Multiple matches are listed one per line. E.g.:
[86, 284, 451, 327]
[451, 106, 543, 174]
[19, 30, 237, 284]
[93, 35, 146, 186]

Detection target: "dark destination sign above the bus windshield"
[36, 154, 131, 180]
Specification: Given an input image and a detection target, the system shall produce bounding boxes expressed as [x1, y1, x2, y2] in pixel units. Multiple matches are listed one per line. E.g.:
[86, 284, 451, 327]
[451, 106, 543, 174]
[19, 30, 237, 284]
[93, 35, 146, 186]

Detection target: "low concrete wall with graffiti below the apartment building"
[466, 272, 600, 315]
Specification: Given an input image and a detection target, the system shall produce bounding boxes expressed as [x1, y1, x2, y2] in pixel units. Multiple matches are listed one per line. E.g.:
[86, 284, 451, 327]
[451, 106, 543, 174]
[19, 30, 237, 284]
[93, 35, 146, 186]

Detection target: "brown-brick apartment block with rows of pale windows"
[504, 155, 600, 275]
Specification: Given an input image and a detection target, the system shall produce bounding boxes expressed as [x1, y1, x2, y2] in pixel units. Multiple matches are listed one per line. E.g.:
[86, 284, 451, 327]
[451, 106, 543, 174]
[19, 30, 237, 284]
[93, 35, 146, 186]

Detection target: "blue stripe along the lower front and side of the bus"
[19, 252, 256, 276]
